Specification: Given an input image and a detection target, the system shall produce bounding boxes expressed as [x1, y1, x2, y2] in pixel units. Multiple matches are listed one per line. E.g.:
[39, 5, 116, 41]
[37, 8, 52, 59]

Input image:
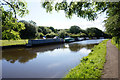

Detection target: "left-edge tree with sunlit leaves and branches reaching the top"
[0, 0, 29, 40]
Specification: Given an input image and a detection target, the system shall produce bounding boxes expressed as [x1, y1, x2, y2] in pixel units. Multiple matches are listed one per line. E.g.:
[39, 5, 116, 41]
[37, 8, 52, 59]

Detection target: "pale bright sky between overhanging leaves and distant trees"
[18, 0, 106, 31]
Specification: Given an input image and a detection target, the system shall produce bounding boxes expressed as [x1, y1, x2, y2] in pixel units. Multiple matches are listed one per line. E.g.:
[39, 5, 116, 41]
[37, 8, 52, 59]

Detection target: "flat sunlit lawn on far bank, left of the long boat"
[0, 40, 28, 46]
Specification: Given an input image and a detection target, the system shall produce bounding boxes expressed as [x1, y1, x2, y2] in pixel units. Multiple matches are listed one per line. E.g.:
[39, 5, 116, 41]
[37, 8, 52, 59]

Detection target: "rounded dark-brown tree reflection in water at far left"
[2, 49, 37, 63]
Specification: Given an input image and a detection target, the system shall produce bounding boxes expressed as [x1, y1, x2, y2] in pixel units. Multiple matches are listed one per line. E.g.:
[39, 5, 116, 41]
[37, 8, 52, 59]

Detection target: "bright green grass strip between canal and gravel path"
[65, 40, 108, 78]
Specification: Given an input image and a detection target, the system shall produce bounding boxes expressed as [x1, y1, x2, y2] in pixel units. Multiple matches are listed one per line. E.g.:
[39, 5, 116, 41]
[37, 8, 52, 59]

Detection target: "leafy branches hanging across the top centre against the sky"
[42, 0, 97, 20]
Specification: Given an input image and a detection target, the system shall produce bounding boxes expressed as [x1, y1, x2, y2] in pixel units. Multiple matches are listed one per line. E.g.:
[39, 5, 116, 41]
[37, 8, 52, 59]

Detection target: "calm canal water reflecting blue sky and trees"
[2, 39, 103, 78]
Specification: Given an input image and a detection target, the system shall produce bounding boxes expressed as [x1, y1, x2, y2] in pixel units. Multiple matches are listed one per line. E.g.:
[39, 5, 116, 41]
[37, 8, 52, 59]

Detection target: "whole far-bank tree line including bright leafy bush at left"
[1, 8, 108, 40]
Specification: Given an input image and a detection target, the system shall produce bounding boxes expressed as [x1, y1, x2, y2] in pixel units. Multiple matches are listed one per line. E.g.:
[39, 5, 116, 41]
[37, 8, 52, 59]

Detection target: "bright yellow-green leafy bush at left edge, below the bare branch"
[1, 7, 25, 40]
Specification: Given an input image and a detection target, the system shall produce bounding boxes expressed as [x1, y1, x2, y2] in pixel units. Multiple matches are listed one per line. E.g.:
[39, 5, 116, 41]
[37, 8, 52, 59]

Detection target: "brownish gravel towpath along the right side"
[101, 40, 118, 78]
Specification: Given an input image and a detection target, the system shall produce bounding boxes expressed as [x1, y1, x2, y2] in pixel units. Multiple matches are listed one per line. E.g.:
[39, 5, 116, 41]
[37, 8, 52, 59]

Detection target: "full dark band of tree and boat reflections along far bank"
[2, 40, 99, 63]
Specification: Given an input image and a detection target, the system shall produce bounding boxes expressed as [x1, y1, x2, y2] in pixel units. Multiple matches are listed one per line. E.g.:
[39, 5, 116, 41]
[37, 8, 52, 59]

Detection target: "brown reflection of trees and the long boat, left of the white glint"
[2, 44, 64, 63]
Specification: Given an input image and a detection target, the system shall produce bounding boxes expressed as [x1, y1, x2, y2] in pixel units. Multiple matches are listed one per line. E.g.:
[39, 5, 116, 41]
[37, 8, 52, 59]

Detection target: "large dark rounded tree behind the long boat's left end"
[20, 20, 37, 39]
